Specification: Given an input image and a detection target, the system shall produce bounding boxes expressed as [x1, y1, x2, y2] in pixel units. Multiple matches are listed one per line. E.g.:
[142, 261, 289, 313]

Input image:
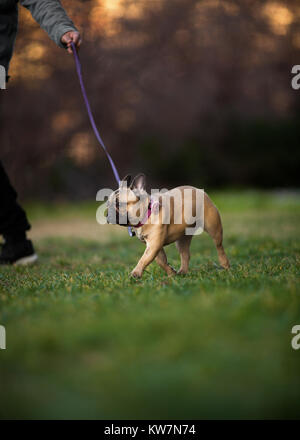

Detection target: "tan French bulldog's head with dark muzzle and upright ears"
[107, 174, 150, 226]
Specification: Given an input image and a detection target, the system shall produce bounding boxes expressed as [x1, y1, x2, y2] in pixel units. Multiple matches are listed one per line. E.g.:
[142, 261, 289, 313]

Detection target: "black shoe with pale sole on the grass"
[0, 240, 38, 265]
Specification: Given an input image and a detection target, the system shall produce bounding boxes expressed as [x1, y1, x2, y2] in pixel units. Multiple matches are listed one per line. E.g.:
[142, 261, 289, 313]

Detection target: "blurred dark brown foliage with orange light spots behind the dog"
[0, 0, 300, 199]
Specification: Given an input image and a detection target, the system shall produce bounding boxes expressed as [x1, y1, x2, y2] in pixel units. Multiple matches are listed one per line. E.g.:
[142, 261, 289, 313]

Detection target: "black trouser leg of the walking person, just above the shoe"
[0, 161, 30, 237]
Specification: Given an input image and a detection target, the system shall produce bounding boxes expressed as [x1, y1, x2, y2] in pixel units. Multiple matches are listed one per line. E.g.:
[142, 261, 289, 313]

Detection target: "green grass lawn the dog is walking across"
[0, 191, 300, 419]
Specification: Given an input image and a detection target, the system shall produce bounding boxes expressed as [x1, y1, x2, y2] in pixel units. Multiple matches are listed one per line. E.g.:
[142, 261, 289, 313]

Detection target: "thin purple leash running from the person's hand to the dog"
[71, 43, 133, 237]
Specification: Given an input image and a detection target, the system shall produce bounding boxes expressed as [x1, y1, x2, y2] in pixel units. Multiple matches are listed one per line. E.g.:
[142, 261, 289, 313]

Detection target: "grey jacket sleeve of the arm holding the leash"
[20, 0, 77, 47]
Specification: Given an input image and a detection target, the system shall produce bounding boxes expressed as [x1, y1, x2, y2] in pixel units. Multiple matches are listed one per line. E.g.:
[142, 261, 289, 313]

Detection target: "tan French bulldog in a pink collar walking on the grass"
[106, 174, 230, 278]
